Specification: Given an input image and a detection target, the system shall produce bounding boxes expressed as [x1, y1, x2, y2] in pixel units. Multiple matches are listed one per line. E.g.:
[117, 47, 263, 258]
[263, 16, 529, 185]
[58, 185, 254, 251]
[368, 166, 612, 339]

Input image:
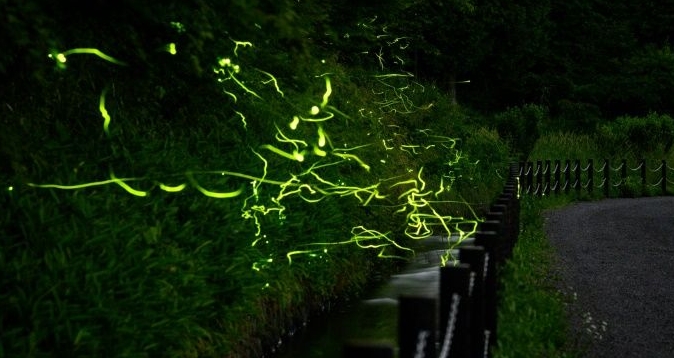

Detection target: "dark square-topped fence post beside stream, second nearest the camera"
[398, 296, 437, 358]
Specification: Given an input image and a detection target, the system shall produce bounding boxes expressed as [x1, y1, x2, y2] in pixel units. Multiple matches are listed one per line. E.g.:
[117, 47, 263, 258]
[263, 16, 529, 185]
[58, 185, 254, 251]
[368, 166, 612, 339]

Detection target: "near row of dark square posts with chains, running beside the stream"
[343, 164, 520, 358]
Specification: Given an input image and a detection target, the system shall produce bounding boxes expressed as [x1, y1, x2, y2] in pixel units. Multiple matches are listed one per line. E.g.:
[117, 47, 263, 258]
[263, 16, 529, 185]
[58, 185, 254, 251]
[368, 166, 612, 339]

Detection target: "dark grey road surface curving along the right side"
[544, 197, 674, 358]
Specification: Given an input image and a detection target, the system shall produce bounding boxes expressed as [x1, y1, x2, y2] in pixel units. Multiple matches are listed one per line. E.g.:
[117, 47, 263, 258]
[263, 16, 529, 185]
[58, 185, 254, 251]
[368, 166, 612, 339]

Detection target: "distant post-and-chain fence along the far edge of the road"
[519, 159, 674, 197]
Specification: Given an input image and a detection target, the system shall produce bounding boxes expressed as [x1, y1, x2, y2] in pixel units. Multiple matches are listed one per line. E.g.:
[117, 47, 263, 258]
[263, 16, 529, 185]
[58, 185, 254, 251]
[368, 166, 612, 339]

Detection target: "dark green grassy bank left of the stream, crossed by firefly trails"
[0, 1, 509, 356]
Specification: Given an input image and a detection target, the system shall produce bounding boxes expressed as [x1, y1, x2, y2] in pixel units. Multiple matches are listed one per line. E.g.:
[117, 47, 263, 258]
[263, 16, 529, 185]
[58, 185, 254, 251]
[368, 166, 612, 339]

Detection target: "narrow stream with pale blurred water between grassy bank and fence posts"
[275, 237, 470, 358]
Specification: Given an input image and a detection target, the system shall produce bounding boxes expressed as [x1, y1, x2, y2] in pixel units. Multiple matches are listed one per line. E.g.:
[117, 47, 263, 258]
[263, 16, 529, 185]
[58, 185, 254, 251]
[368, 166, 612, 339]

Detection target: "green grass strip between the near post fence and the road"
[494, 197, 578, 358]
